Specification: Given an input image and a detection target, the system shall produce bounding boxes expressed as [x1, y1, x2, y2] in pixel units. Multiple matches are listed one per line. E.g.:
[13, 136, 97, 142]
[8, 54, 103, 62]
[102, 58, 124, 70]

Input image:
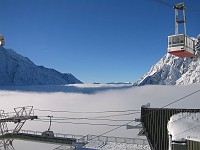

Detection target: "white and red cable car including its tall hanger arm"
[168, 3, 195, 58]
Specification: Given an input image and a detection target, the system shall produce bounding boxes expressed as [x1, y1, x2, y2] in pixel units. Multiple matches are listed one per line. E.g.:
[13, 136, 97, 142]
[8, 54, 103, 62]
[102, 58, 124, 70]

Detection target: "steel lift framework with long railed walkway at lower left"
[0, 106, 148, 150]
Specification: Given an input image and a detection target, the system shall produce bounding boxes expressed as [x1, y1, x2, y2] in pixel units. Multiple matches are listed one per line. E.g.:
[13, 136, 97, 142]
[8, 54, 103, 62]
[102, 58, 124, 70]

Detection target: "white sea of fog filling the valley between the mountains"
[0, 84, 200, 150]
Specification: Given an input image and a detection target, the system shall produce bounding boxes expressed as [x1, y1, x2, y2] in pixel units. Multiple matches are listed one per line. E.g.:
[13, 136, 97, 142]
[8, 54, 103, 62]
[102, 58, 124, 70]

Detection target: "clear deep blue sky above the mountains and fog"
[0, 0, 200, 83]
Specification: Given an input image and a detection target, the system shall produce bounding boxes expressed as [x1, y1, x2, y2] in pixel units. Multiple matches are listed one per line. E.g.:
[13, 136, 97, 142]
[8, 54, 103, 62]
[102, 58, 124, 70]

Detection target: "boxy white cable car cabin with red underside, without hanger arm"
[168, 34, 194, 58]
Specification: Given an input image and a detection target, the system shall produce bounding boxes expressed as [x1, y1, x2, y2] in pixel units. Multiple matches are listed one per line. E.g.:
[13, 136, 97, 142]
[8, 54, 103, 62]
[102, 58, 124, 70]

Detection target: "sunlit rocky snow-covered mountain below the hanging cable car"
[134, 42, 200, 85]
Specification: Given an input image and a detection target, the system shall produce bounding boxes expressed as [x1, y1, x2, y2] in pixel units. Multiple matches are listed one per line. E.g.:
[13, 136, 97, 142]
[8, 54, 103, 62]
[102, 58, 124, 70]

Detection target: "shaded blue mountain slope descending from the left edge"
[0, 46, 82, 86]
